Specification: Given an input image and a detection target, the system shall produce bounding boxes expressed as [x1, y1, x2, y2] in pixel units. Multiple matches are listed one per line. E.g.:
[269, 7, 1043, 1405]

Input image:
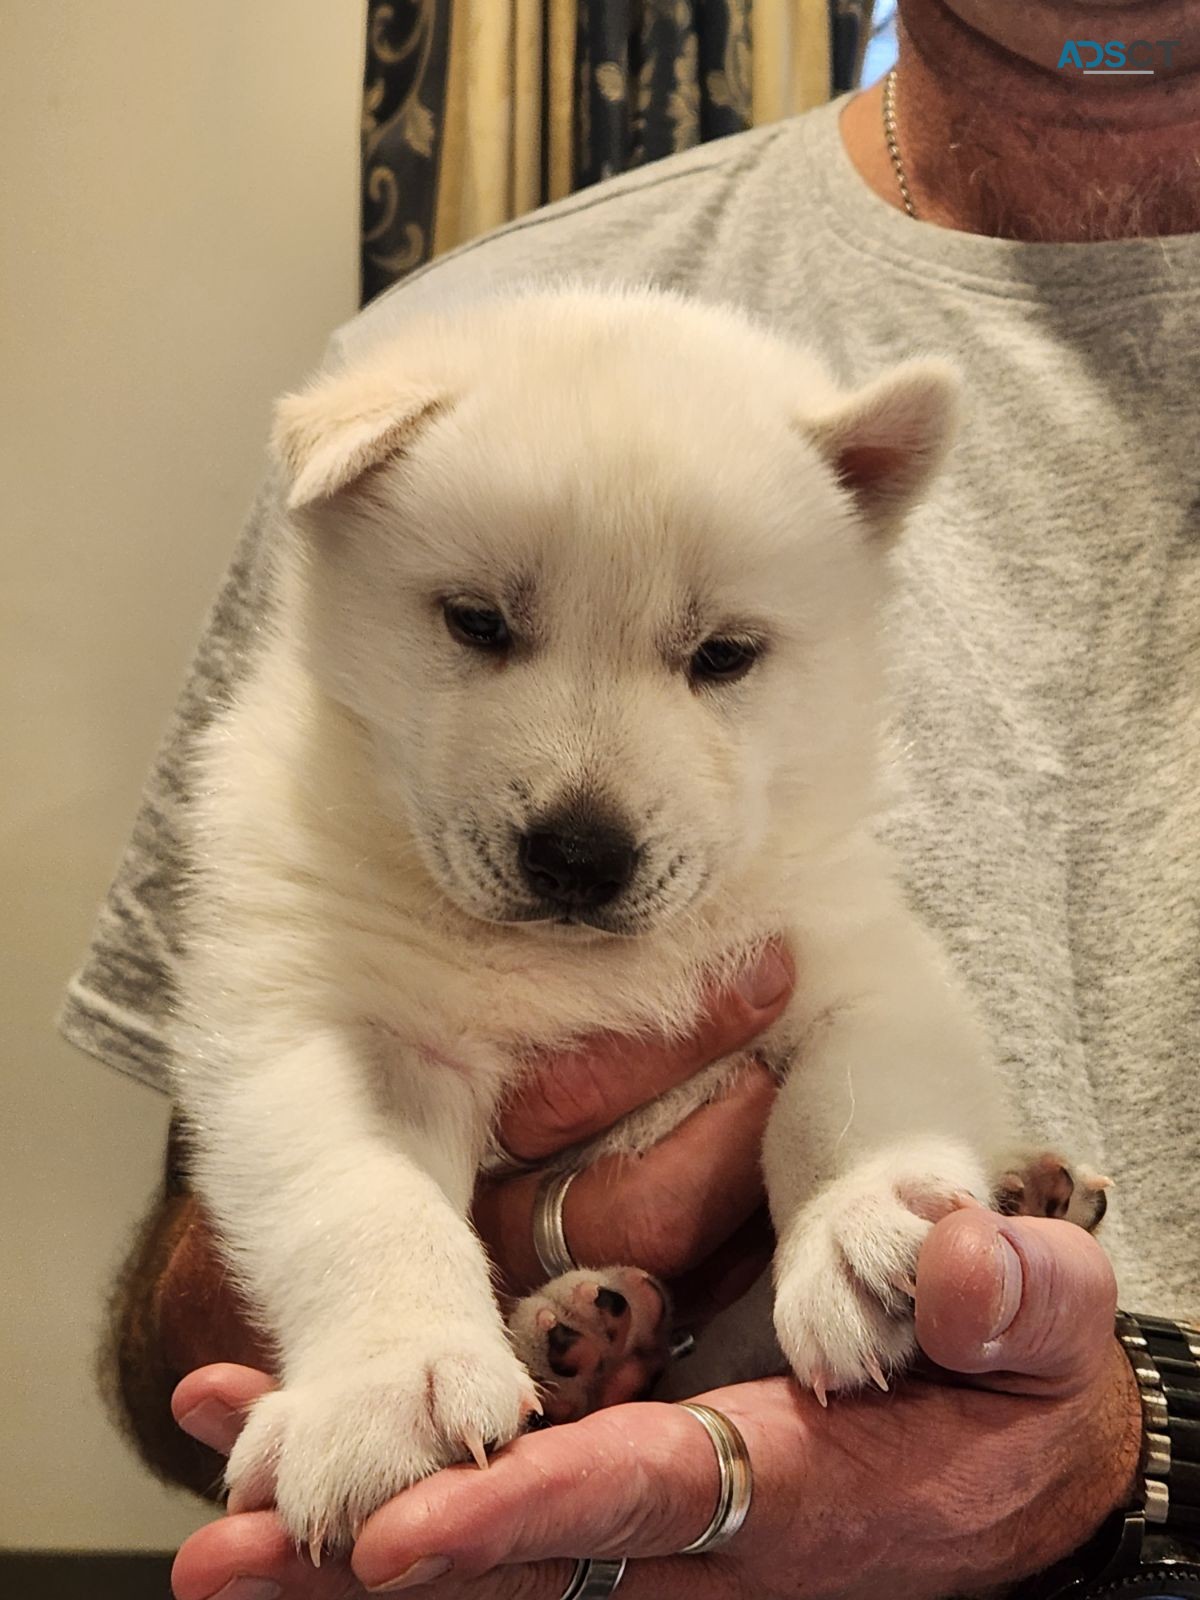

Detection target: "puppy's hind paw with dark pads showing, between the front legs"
[509, 1267, 670, 1422]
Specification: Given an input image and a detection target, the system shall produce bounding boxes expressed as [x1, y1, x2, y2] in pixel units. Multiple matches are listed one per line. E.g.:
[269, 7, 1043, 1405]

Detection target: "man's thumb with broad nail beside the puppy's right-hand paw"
[917, 1206, 1117, 1395]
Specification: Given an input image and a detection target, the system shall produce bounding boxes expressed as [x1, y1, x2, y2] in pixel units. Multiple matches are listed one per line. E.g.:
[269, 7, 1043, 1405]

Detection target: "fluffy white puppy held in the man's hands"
[176, 285, 1107, 1542]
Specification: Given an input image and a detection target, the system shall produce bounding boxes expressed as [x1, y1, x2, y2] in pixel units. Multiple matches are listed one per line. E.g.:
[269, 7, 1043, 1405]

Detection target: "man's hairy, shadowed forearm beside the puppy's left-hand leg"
[101, 1186, 272, 1499]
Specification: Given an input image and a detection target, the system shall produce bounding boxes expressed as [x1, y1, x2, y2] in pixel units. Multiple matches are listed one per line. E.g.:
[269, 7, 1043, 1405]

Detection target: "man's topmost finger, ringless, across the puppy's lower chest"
[499, 944, 795, 1162]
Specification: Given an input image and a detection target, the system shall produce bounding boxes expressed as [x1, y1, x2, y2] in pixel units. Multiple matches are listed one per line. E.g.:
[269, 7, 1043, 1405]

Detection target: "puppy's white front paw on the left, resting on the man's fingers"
[226, 1330, 538, 1563]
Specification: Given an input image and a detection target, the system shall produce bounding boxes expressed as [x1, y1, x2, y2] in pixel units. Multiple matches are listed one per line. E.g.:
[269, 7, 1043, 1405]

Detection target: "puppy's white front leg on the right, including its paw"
[763, 904, 1005, 1395]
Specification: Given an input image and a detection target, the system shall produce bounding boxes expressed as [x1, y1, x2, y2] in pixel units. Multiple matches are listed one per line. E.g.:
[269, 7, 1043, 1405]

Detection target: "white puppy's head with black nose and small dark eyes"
[275, 286, 954, 934]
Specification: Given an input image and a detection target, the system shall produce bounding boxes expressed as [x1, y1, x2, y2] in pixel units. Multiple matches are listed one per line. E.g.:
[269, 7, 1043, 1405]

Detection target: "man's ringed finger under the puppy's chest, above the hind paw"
[474, 1062, 776, 1294]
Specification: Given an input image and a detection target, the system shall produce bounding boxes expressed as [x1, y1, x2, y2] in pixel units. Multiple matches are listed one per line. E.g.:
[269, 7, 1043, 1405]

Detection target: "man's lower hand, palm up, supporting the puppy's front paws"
[173, 1208, 1141, 1600]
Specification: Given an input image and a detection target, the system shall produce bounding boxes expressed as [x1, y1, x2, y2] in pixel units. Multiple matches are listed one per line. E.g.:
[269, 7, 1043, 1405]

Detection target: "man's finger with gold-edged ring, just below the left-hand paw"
[352, 1386, 758, 1594]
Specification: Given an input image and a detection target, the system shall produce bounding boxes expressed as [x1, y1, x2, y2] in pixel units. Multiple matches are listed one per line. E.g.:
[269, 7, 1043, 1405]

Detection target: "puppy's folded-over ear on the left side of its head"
[270, 373, 451, 510]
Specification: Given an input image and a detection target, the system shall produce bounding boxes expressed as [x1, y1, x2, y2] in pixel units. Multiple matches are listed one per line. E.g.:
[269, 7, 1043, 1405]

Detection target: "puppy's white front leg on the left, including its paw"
[181, 1029, 536, 1552]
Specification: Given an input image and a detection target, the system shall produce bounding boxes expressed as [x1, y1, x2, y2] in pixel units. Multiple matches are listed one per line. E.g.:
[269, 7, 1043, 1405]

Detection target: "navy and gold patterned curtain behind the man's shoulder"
[362, 0, 838, 302]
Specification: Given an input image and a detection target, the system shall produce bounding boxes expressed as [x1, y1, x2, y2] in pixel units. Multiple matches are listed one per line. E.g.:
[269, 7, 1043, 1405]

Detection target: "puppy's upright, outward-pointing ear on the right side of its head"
[800, 362, 960, 544]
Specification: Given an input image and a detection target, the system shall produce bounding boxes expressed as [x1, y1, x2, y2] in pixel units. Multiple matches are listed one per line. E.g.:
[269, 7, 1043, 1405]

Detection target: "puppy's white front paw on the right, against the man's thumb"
[774, 1146, 989, 1405]
